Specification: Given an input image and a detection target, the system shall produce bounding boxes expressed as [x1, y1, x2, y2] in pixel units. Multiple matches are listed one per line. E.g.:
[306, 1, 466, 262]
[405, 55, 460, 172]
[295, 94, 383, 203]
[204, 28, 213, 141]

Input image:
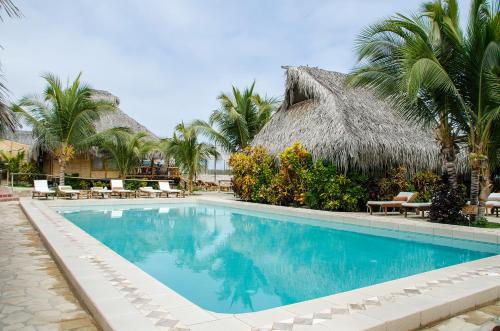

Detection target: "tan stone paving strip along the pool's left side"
[0, 202, 98, 331]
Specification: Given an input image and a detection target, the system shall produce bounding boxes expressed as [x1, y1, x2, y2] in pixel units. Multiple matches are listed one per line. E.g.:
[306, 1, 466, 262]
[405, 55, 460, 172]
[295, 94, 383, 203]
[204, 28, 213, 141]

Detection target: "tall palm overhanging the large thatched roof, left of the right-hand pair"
[349, 0, 465, 188]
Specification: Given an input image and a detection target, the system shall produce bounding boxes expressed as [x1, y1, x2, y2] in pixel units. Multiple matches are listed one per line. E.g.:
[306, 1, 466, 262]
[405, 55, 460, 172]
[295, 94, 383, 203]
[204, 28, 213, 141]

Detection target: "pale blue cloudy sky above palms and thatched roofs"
[0, 0, 469, 136]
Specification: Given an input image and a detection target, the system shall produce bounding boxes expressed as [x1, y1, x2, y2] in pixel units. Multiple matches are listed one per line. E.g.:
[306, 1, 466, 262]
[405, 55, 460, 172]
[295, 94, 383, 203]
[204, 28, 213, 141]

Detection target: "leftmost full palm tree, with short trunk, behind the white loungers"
[13, 73, 116, 185]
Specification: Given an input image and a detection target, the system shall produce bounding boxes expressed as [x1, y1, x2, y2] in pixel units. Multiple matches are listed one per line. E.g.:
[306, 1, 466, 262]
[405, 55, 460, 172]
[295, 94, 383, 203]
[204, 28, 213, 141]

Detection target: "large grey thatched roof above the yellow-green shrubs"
[252, 66, 441, 172]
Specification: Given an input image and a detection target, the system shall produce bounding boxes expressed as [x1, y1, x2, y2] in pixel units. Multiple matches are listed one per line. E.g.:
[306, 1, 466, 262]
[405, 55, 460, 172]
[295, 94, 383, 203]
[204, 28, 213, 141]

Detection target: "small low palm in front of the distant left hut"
[98, 130, 156, 178]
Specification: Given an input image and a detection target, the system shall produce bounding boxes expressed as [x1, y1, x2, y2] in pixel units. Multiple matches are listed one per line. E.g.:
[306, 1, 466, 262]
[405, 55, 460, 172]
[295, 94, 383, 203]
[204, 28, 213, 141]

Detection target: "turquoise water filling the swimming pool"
[59, 203, 498, 313]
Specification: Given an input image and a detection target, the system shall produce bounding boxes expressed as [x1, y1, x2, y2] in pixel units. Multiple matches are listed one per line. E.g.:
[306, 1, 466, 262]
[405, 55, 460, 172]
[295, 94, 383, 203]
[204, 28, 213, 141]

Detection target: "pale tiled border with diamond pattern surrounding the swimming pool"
[15, 197, 500, 331]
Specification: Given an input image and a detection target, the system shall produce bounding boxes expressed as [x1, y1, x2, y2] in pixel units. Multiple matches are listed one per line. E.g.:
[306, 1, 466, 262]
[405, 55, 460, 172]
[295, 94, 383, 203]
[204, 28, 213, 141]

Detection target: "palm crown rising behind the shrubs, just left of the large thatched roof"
[193, 82, 278, 152]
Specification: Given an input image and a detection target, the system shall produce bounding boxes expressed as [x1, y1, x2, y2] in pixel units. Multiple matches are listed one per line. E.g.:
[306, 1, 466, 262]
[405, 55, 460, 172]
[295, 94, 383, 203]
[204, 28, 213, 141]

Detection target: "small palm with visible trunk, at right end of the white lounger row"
[163, 123, 218, 192]
